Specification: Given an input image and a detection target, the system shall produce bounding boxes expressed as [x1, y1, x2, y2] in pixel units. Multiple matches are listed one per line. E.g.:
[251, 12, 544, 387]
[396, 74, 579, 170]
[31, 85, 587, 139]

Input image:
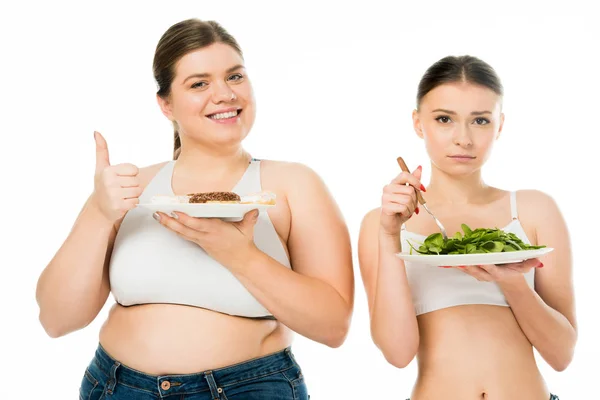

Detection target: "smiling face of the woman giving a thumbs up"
[158, 43, 255, 147]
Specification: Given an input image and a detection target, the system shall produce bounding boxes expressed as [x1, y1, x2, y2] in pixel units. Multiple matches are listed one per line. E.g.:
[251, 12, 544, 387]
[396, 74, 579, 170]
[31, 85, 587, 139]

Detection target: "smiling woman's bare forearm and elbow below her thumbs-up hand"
[36, 197, 116, 338]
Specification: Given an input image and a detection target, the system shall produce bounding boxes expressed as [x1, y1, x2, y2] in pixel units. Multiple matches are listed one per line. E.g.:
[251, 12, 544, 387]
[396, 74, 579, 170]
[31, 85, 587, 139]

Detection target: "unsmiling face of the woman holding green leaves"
[413, 82, 504, 175]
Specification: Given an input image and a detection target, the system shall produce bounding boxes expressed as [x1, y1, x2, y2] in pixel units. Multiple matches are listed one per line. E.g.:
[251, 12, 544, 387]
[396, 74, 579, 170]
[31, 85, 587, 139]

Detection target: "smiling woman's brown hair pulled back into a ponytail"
[152, 19, 243, 160]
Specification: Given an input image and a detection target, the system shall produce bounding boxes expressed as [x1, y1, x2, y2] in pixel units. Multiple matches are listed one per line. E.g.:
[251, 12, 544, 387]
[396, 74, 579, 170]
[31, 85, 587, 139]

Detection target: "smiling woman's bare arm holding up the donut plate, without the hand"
[229, 164, 354, 347]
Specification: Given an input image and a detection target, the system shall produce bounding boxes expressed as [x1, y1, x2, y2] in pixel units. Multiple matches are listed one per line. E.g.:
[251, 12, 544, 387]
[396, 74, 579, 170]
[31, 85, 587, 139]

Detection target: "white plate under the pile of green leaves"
[396, 247, 554, 267]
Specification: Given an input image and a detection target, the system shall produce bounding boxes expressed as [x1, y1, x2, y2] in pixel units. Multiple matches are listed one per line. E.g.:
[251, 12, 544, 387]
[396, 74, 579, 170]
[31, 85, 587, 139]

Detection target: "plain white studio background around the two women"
[0, 1, 600, 400]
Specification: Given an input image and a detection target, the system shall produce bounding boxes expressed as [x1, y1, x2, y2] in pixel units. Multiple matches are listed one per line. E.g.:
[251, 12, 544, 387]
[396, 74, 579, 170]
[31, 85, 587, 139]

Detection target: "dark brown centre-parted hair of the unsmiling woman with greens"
[417, 56, 504, 109]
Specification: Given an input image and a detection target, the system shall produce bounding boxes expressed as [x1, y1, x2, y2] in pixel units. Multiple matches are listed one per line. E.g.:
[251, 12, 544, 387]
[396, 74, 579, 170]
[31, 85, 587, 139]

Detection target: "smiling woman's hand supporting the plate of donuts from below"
[155, 210, 258, 268]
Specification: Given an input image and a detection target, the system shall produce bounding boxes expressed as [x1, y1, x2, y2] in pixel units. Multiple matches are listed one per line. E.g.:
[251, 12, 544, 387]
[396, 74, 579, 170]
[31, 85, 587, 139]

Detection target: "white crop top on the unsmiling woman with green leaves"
[400, 192, 535, 315]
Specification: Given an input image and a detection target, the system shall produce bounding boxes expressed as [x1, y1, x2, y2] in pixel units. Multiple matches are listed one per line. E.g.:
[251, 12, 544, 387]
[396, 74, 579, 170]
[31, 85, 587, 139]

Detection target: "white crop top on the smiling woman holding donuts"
[109, 159, 291, 318]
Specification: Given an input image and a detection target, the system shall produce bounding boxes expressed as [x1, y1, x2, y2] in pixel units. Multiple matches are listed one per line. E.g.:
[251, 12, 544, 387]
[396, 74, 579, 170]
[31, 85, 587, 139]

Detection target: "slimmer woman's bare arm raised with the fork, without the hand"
[358, 209, 419, 368]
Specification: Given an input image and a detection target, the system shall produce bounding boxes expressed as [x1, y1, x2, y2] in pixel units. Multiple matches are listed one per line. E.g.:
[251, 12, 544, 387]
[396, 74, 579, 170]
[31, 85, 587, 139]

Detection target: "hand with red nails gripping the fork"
[380, 166, 425, 235]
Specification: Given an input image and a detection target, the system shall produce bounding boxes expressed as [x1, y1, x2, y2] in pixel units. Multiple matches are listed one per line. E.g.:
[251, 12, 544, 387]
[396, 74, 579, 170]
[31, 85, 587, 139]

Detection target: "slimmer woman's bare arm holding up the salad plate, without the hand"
[500, 191, 577, 371]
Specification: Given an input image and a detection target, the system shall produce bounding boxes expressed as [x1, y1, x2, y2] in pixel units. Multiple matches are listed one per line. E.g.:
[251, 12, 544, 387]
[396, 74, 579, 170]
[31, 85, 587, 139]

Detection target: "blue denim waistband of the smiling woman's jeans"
[93, 345, 297, 396]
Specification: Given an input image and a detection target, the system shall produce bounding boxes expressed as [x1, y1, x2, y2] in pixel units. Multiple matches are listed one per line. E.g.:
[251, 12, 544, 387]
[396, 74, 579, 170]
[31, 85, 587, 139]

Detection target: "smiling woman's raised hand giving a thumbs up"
[92, 132, 142, 222]
